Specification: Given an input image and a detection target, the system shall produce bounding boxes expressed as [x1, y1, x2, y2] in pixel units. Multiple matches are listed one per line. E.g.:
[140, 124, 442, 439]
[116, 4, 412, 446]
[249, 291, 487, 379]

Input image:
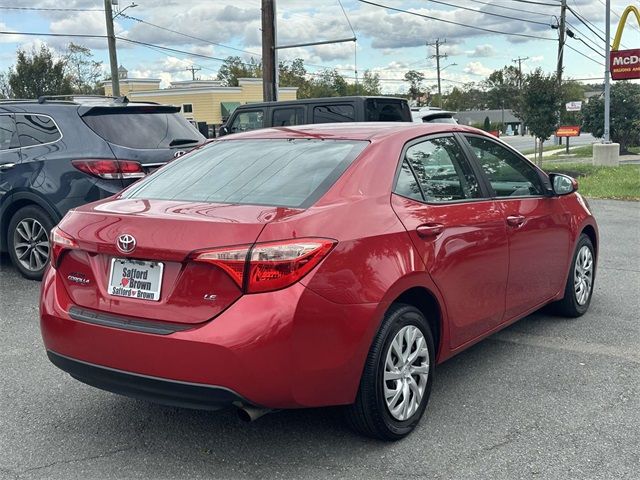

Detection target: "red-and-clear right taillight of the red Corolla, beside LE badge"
[192, 238, 337, 293]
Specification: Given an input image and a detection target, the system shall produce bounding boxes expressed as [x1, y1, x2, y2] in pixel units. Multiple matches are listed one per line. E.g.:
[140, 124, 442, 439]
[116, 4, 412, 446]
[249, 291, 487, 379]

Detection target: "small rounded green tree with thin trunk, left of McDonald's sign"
[515, 68, 562, 163]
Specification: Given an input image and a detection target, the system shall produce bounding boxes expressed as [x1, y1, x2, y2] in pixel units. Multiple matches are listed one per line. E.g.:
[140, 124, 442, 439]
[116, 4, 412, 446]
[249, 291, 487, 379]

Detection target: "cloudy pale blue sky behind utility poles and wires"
[0, 0, 640, 92]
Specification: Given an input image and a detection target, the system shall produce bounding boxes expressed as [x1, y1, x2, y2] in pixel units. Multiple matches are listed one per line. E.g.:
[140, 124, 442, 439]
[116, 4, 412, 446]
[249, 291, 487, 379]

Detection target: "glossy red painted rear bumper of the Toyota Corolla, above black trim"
[40, 268, 384, 408]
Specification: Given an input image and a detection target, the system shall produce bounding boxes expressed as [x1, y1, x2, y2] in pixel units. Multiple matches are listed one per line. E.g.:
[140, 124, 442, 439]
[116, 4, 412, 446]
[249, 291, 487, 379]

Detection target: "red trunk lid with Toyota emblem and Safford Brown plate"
[57, 199, 300, 324]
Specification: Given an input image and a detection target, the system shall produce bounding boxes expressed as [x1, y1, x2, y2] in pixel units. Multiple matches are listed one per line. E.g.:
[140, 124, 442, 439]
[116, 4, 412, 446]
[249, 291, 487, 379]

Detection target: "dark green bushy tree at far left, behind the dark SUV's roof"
[9, 45, 73, 98]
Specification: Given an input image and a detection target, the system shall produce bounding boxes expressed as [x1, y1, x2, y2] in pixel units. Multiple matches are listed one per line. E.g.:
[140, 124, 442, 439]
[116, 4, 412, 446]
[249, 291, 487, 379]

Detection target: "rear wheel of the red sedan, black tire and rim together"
[345, 303, 435, 440]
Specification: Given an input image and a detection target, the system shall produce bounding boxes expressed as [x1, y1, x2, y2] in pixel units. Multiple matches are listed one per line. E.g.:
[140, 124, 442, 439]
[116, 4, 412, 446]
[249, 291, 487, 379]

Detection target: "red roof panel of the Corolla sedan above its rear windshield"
[218, 122, 484, 140]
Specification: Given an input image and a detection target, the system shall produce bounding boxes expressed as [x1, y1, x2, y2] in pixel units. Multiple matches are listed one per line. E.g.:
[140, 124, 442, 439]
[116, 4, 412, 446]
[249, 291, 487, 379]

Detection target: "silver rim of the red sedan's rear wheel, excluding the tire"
[383, 325, 429, 421]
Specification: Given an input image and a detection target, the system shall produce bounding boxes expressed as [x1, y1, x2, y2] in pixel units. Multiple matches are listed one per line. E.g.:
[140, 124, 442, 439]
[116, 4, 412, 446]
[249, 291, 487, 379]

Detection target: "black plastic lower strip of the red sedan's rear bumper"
[47, 351, 246, 410]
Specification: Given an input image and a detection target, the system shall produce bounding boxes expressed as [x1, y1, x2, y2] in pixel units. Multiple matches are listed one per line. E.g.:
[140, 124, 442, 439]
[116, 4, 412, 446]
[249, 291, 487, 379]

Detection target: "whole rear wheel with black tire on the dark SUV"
[7, 205, 53, 280]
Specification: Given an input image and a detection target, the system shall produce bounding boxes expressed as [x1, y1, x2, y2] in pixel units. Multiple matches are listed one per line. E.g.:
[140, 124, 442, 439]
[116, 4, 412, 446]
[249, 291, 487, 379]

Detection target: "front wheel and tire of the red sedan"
[553, 233, 596, 318]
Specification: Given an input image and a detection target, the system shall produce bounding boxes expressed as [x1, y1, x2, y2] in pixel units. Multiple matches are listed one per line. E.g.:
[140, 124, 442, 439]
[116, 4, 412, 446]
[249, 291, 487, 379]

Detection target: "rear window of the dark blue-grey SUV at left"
[82, 109, 204, 149]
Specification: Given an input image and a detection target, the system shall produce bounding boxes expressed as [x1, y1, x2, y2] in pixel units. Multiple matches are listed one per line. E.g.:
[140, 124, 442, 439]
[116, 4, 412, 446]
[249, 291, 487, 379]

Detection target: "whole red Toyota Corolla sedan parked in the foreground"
[40, 123, 598, 439]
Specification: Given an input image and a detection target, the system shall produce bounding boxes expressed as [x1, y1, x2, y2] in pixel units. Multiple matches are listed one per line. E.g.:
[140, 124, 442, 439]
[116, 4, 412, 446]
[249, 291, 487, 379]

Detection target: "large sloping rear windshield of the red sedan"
[125, 139, 368, 208]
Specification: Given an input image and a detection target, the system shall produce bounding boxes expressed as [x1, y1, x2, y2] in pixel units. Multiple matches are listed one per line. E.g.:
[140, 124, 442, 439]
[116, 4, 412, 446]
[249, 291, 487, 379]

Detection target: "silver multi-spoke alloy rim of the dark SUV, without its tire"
[13, 218, 49, 272]
